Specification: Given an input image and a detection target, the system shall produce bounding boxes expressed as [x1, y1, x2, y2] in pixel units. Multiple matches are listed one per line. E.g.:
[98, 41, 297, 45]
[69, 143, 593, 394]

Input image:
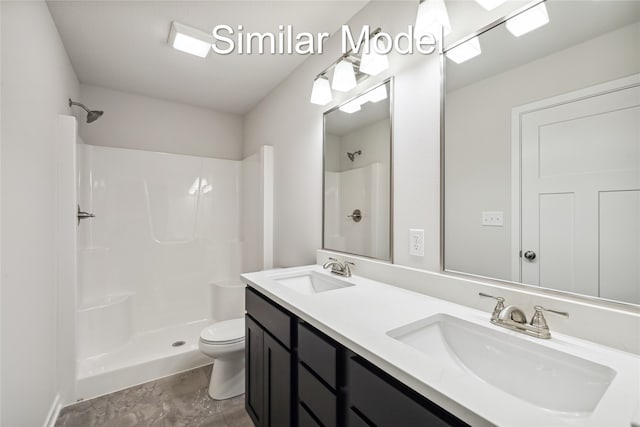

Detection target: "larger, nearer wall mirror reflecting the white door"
[444, 0, 640, 304]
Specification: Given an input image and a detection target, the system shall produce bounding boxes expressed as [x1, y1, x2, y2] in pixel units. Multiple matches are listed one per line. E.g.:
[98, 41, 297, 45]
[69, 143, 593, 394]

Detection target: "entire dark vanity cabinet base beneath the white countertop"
[245, 287, 466, 427]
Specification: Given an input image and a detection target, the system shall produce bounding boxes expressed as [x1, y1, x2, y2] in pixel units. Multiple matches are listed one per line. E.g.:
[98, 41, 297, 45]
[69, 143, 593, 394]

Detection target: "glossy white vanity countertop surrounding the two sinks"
[242, 265, 640, 427]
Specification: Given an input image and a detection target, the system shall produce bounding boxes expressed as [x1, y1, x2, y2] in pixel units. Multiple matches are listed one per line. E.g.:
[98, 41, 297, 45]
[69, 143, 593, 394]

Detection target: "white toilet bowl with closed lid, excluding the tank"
[198, 317, 244, 400]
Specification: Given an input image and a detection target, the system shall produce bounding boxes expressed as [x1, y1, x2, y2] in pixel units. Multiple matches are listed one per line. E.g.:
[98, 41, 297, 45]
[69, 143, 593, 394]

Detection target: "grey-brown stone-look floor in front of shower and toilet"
[56, 365, 253, 427]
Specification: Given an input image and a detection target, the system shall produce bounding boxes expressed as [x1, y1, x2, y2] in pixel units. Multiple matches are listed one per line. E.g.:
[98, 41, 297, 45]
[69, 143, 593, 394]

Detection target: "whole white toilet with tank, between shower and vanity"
[199, 281, 244, 400]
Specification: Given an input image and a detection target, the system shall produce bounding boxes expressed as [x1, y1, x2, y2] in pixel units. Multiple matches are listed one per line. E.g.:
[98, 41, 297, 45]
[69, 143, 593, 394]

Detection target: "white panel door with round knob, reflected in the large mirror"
[520, 80, 640, 303]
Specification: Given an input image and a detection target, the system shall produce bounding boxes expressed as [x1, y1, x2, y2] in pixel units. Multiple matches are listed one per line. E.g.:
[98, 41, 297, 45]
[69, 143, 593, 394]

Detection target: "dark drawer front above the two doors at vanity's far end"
[245, 287, 291, 349]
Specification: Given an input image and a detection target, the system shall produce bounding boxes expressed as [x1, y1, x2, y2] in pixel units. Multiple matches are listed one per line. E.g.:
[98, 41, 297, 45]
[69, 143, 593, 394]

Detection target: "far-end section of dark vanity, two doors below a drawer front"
[245, 288, 294, 427]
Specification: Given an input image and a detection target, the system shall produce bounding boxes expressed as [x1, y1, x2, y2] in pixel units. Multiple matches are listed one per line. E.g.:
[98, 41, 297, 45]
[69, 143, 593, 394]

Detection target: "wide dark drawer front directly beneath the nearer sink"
[348, 357, 466, 427]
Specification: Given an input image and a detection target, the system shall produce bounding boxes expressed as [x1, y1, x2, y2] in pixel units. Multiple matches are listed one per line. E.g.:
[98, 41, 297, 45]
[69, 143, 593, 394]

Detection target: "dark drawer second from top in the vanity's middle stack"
[298, 365, 337, 427]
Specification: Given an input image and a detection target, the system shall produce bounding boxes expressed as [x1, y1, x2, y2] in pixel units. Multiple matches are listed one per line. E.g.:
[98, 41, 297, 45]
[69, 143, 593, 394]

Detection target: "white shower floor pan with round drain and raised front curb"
[75, 320, 212, 400]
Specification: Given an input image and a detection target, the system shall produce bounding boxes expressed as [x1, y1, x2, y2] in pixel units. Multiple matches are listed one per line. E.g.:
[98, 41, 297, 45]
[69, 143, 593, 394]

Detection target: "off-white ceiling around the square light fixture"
[47, 0, 368, 114]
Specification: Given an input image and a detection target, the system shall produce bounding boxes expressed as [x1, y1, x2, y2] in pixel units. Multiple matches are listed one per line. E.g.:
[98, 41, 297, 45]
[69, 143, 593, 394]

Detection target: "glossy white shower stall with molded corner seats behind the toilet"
[75, 144, 250, 399]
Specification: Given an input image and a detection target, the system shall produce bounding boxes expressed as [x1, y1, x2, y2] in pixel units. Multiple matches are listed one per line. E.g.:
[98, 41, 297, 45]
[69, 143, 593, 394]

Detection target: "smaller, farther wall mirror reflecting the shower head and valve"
[323, 80, 393, 261]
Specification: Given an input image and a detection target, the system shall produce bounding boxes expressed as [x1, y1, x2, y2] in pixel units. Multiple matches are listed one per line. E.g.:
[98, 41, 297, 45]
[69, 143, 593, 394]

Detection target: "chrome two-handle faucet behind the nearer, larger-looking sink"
[479, 292, 569, 339]
